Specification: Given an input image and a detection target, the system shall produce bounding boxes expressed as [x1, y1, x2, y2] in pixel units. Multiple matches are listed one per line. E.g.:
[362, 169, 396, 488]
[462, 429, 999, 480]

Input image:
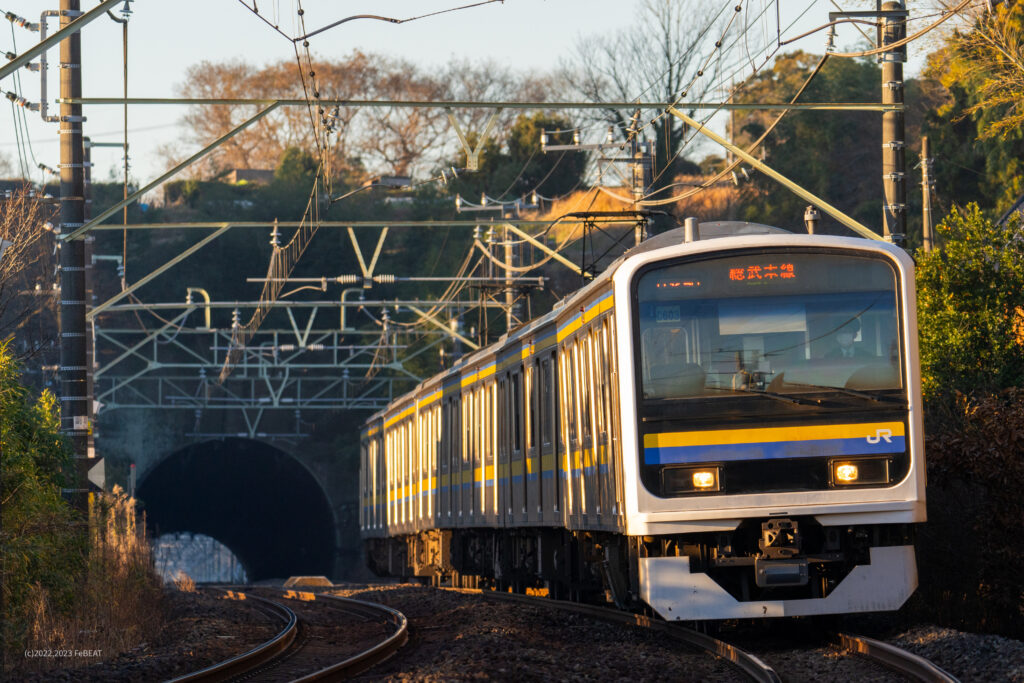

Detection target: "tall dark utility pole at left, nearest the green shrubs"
[58, 0, 91, 466]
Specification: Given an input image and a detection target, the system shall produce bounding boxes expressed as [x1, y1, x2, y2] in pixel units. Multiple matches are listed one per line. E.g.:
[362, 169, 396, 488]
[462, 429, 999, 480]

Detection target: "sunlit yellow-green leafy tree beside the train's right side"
[918, 204, 1024, 399]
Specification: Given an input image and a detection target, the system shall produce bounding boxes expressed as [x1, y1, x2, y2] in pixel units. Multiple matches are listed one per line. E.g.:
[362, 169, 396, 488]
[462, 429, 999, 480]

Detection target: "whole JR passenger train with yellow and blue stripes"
[359, 221, 926, 622]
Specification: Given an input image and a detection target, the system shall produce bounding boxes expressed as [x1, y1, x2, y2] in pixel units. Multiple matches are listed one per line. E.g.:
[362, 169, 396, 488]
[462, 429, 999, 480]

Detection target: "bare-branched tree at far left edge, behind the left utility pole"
[0, 184, 58, 359]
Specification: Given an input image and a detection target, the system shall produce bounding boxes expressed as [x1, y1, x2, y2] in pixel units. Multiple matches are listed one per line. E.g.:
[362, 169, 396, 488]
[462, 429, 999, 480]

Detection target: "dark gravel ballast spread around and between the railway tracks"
[12, 584, 1024, 683]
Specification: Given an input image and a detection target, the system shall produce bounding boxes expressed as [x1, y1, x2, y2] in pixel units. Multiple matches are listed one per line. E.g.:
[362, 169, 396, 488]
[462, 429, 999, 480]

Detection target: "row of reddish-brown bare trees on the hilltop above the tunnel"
[164, 51, 553, 183]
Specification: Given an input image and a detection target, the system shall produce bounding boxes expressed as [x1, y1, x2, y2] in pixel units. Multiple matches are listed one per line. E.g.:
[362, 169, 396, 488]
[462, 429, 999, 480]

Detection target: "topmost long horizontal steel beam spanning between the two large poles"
[56, 97, 903, 112]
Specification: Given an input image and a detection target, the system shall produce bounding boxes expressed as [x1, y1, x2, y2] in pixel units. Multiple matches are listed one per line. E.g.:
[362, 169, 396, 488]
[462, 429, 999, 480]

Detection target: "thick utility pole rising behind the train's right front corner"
[881, 0, 907, 243]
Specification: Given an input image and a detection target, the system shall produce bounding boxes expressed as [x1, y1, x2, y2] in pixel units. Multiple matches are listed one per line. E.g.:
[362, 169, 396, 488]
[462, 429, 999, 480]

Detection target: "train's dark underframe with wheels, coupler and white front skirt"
[366, 517, 916, 621]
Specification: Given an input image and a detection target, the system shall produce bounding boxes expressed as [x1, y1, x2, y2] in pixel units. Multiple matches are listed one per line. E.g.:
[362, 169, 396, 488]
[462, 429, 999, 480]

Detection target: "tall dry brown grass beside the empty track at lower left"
[14, 486, 162, 671]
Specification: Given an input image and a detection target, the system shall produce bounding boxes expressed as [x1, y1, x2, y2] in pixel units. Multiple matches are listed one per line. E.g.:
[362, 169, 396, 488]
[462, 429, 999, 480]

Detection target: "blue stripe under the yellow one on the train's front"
[644, 436, 906, 465]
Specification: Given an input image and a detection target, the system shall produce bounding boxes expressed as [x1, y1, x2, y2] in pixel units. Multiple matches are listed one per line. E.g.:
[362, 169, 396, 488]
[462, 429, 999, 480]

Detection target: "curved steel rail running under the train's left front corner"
[479, 591, 782, 683]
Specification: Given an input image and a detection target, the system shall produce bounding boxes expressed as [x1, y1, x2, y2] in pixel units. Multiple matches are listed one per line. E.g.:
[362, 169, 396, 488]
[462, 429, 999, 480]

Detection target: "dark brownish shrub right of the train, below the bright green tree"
[915, 388, 1024, 638]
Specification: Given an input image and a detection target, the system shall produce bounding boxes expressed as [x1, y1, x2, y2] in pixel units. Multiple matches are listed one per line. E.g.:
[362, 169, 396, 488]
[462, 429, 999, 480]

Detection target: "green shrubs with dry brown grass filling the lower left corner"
[0, 343, 161, 673]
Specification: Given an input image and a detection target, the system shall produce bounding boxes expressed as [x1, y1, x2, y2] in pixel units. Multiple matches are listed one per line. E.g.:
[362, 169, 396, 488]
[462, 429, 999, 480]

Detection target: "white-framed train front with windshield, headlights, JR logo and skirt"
[615, 233, 925, 620]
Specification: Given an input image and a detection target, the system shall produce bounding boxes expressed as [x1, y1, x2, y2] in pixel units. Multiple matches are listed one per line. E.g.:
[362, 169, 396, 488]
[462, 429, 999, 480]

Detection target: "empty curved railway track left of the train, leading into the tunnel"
[172, 588, 409, 683]
